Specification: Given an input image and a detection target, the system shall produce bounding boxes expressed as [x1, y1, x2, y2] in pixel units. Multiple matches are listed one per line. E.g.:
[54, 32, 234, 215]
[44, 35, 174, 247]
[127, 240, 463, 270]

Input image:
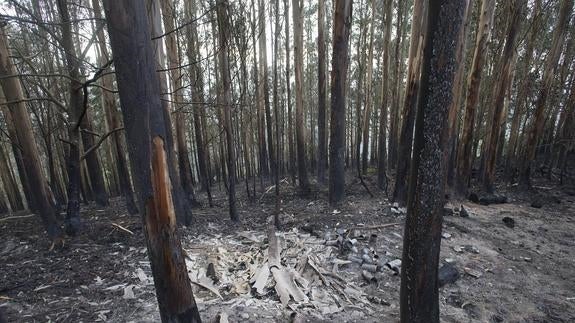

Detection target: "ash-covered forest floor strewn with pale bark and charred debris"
[0, 173, 575, 322]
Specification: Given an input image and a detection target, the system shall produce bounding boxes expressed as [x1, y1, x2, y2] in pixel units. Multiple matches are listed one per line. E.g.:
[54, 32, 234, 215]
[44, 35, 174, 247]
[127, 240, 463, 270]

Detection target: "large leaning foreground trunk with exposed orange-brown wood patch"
[104, 0, 201, 322]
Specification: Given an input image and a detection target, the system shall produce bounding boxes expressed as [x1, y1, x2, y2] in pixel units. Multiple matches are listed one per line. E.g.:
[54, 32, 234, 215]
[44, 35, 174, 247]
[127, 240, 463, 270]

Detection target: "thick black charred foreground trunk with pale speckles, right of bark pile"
[400, 0, 465, 323]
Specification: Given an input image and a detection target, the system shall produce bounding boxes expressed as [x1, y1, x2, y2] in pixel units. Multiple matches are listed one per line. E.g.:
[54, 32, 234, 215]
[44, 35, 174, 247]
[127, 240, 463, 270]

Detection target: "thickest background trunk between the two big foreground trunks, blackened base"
[329, 0, 352, 205]
